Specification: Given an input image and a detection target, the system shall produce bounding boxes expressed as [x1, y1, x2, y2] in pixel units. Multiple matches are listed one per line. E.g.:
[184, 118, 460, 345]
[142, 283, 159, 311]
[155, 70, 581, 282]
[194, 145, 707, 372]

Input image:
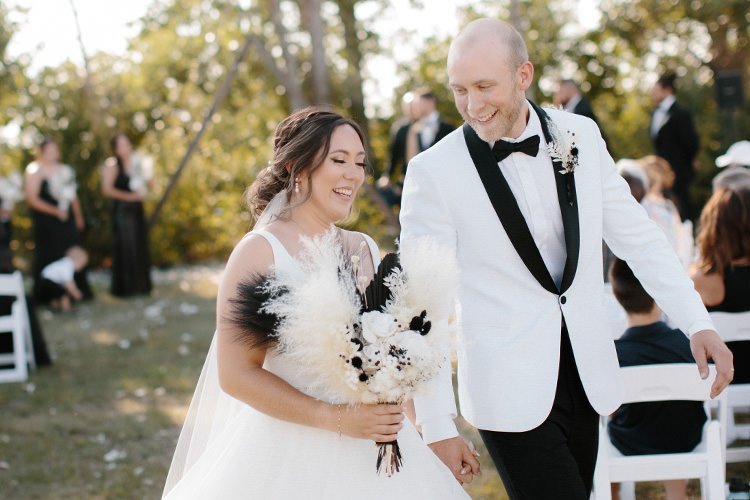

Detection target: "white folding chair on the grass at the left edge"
[0, 271, 36, 382]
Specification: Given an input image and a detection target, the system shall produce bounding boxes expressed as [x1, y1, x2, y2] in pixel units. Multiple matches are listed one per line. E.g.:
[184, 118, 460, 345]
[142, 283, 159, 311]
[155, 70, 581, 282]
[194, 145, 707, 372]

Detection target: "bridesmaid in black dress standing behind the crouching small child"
[24, 138, 93, 303]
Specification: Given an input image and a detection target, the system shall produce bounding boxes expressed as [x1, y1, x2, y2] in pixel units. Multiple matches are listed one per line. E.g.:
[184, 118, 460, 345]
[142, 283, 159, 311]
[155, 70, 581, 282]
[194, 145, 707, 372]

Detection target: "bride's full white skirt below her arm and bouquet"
[165, 405, 469, 500]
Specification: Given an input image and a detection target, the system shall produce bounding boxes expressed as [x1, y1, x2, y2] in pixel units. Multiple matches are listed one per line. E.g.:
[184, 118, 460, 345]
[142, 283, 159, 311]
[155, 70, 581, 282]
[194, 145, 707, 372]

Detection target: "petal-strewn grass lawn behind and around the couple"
[0, 265, 750, 500]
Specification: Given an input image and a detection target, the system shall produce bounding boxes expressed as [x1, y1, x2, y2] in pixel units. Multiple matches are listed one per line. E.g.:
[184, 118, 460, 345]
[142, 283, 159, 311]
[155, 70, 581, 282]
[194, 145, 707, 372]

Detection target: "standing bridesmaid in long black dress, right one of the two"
[102, 134, 151, 297]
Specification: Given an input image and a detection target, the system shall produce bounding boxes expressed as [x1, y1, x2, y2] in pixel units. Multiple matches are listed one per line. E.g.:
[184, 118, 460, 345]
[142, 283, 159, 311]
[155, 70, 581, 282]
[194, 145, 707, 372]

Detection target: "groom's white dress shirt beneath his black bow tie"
[499, 103, 567, 287]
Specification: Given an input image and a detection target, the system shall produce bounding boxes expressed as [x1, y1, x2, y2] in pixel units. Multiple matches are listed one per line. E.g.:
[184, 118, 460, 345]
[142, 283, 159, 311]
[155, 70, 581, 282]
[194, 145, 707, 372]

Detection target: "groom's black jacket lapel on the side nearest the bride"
[463, 124, 567, 294]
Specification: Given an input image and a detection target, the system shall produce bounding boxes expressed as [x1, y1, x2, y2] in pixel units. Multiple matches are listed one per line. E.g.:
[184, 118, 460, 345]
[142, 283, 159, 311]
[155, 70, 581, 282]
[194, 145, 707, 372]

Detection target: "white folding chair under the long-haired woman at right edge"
[710, 311, 750, 463]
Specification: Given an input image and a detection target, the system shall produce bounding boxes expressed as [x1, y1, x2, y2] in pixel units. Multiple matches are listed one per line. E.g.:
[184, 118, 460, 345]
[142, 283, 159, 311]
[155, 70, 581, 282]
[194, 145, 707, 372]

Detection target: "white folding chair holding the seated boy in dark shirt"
[594, 363, 727, 500]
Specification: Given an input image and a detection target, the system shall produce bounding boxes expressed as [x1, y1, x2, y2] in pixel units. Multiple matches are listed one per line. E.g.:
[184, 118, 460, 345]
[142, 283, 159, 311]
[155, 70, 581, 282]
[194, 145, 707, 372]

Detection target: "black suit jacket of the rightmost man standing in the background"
[651, 102, 699, 182]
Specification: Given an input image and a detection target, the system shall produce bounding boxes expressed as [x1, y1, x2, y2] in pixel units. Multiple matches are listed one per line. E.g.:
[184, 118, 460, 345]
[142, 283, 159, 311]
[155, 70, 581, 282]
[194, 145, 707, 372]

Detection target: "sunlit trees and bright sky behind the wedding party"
[0, 0, 750, 266]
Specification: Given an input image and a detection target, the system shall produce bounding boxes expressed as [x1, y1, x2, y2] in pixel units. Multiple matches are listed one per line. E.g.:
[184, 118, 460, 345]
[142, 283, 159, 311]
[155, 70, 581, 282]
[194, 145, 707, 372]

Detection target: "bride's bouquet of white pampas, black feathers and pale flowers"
[231, 231, 458, 476]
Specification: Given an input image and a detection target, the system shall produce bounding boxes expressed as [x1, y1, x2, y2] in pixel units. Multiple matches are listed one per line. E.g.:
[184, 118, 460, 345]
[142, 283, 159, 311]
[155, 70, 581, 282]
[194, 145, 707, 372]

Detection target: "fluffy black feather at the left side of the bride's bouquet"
[224, 275, 286, 349]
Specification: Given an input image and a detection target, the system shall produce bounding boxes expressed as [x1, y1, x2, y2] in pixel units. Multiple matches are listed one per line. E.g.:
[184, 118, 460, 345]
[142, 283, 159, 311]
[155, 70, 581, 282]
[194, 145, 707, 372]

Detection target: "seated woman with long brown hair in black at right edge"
[691, 184, 750, 384]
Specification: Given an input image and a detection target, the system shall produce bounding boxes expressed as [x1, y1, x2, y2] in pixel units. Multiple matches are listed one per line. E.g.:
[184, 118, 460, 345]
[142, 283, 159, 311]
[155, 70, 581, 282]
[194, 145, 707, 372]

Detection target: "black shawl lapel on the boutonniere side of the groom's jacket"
[529, 101, 581, 293]
